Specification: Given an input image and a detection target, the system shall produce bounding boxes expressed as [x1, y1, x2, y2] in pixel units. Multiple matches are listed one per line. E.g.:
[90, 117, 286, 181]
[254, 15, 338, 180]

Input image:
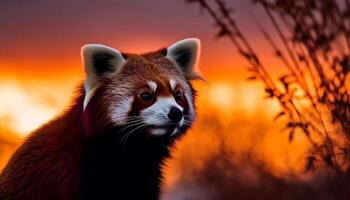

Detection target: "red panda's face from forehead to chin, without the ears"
[102, 54, 195, 135]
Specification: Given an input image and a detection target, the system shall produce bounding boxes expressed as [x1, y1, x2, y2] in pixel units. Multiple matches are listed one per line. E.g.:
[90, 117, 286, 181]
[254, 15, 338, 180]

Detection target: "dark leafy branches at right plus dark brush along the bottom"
[185, 0, 350, 199]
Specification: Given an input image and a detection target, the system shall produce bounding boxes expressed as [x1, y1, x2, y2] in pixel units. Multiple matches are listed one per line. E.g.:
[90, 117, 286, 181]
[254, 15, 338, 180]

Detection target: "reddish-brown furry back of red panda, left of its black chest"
[0, 94, 84, 200]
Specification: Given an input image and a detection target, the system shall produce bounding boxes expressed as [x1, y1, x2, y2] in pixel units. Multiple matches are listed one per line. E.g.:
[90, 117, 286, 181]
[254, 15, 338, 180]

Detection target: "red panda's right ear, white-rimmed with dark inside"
[166, 38, 205, 81]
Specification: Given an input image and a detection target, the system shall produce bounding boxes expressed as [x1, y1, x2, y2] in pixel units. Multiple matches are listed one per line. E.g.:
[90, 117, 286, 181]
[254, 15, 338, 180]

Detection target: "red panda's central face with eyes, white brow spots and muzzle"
[128, 79, 191, 135]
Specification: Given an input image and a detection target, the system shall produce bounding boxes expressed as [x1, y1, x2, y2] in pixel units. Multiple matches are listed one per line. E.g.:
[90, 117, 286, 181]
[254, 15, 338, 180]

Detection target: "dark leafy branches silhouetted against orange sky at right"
[187, 0, 350, 175]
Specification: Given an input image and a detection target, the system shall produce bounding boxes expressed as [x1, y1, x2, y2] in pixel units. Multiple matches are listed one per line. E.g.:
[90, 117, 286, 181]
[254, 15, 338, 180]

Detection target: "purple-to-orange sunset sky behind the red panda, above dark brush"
[0, 0, 312, 194]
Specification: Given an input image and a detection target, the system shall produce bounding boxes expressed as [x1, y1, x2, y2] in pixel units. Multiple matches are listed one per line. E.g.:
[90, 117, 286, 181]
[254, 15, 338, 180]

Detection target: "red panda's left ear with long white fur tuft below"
[81, 44, 126, 110]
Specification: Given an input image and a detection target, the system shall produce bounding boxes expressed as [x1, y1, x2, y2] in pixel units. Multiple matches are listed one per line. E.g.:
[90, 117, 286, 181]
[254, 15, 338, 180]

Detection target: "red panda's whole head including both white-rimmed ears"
[82, 38, 202, 135]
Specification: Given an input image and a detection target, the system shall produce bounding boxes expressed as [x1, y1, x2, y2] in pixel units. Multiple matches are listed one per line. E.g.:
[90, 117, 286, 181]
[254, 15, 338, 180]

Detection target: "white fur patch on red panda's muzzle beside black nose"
[140, 97, 184, 126]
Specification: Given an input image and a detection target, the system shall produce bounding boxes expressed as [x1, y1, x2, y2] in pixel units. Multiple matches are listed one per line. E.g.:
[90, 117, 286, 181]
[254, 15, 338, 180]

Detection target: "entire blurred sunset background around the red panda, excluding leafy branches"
[0, 0, 348, 200]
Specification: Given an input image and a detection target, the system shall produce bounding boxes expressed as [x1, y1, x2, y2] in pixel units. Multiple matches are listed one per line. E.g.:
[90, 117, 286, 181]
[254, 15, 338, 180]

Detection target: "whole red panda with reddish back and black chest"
[0, 38, 201, 200]
